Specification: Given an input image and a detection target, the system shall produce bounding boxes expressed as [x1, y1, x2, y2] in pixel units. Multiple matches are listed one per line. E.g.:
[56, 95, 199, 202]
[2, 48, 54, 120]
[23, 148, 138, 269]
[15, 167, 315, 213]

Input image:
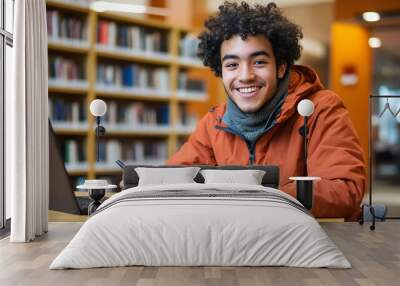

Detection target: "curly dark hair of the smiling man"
[197, 1, 303, 77]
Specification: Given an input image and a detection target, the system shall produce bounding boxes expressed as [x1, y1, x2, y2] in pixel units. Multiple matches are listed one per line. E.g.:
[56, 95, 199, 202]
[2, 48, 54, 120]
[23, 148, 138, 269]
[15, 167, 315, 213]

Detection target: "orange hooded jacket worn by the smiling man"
[167, 66, 366, 220]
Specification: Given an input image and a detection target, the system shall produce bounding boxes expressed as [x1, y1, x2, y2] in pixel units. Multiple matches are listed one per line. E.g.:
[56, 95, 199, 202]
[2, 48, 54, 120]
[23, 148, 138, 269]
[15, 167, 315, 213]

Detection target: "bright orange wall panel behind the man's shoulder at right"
[330, 22, 372, 159]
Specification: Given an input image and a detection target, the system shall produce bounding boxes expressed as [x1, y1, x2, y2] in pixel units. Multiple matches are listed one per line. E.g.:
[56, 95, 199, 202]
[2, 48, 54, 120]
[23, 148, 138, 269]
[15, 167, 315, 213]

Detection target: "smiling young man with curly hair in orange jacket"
[167, 2, 365, 219]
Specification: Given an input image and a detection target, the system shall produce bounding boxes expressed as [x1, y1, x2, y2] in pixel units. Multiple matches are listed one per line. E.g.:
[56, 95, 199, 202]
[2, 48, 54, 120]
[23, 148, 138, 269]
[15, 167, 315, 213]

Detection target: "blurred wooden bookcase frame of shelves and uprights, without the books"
[46, 0, 216, 179]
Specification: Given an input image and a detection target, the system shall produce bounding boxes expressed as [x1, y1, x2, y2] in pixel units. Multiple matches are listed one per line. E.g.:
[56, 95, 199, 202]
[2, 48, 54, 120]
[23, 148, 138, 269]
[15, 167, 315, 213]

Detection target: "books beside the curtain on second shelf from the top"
[49, 55, 85, 80]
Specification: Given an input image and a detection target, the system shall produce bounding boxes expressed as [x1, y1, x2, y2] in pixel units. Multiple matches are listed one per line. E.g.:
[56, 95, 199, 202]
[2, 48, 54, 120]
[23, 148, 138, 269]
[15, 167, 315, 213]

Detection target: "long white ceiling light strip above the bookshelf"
[90, 1, 168, 16]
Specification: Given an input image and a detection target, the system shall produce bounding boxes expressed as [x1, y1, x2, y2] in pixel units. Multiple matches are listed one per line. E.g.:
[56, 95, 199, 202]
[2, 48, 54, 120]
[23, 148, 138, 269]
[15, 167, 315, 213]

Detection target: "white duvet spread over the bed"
[50, 184, 351, 269]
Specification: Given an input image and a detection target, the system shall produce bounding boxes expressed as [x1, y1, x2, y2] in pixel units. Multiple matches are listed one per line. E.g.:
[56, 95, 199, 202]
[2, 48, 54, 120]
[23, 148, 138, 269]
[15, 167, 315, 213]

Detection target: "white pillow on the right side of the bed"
[200, 169, 265, 185]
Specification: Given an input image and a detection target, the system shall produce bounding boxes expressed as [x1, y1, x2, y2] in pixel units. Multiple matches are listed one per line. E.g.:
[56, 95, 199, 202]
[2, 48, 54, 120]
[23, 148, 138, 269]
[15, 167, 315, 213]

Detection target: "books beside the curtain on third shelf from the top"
[49, 98, 86, 123]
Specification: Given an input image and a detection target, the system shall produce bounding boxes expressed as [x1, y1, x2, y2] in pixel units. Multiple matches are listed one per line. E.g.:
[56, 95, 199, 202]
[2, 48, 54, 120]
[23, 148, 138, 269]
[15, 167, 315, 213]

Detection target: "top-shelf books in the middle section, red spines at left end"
[97, 20, 168, 53]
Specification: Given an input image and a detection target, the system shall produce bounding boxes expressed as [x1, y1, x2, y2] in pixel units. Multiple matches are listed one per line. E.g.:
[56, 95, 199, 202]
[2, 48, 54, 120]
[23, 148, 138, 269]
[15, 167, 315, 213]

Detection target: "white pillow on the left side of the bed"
[135, 167, 200, 186]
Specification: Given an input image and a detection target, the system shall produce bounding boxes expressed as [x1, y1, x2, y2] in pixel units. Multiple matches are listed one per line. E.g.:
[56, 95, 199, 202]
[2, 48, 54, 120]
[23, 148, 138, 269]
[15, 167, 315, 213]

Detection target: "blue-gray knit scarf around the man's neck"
[222, 69, 290, 146]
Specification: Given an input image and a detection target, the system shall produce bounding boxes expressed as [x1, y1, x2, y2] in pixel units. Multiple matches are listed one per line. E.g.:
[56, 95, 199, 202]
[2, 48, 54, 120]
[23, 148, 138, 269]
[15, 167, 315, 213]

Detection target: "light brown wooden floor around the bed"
[0, 222, 400, 286]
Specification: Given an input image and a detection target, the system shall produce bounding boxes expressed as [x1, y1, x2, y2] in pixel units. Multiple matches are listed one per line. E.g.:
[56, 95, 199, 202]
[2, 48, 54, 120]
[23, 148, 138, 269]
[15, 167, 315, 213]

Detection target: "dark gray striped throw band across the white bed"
[91, 189, 311, 216]
